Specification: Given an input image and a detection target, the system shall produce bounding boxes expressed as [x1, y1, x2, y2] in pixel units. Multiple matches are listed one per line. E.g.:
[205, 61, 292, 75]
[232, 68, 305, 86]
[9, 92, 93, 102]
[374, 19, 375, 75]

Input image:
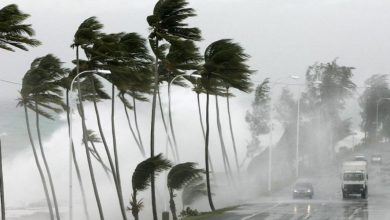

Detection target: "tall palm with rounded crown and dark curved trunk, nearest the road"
[196, 39, 253, 210]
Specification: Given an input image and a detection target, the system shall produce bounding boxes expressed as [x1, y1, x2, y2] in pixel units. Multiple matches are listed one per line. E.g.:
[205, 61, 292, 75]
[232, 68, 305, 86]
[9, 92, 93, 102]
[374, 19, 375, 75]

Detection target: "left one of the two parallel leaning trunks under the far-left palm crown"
[24, 104, 54, 220]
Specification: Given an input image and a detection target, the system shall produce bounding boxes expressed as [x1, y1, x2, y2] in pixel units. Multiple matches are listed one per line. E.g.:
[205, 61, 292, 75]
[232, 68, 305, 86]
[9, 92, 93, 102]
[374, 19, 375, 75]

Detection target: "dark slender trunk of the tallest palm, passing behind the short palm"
[150, 39, 159, 220]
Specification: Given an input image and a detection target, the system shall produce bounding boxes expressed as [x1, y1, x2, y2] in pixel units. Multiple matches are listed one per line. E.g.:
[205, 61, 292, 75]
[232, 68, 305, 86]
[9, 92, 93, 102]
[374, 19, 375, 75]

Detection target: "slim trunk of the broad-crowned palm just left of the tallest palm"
[111, 83, 127, 220]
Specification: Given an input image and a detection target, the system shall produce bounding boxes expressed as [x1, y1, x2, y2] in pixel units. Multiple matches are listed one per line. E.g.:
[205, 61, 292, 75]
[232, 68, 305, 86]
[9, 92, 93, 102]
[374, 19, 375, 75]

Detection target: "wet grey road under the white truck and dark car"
[210, 147, 390, 220]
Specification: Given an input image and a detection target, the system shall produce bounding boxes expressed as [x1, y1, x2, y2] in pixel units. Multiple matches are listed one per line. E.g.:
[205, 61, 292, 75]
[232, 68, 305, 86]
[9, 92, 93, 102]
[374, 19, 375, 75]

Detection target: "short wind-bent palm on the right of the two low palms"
[167, 162, 204, 220]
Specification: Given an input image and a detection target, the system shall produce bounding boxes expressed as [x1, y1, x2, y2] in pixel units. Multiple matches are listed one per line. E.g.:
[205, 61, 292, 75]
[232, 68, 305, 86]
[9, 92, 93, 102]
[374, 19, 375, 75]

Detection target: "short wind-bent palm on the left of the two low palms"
[130, 154, 172, 220]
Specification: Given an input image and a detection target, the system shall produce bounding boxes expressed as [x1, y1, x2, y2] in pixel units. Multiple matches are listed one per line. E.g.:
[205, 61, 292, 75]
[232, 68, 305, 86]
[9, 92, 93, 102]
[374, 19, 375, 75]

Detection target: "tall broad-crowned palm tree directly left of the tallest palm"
[90, 33, 152, 219]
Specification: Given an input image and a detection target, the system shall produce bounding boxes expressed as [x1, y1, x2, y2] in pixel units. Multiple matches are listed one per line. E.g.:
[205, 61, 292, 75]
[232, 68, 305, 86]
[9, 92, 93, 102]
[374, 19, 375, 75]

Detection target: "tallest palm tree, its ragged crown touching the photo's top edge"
[147, 0, 201, 217]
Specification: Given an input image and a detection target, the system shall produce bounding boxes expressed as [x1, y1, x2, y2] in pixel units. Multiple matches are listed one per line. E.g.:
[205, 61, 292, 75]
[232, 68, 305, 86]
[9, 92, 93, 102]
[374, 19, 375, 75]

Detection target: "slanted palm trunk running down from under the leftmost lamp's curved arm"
[77, 79, 104, 220]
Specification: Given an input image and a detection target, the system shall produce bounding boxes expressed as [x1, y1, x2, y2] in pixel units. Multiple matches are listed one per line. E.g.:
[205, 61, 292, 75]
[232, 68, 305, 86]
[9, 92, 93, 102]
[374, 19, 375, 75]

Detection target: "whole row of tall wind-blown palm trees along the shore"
[0, 0, 253, 220]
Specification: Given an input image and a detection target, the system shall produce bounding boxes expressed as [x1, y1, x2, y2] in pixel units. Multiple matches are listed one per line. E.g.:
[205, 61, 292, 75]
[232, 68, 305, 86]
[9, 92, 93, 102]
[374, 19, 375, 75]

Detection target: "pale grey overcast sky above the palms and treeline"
[0, 0, 390, 98]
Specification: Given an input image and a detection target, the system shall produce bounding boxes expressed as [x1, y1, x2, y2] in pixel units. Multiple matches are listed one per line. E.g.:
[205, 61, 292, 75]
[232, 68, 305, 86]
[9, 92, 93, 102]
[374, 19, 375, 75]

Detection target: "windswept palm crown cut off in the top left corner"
[0, 4, 41, 51]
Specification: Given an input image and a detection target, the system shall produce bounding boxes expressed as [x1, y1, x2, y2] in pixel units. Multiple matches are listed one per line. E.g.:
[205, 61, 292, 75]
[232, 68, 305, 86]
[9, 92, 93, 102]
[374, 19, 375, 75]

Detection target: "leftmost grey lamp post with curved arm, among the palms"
[68, 70, 111, 220]
